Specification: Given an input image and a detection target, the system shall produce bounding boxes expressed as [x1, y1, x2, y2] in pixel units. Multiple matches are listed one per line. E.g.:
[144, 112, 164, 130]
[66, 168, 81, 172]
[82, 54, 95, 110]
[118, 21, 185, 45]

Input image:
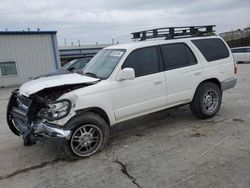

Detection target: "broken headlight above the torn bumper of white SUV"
[38, 99, 71, 121]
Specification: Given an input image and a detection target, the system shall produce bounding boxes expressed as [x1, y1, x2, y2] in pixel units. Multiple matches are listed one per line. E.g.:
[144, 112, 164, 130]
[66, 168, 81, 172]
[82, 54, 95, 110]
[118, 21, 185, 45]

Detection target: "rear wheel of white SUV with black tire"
[190, 82, 222, 119]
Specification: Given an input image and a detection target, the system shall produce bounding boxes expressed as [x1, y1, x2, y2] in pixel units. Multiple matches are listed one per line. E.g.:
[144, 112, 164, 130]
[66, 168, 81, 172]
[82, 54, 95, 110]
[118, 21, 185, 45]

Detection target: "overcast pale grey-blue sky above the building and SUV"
[0, 0, 250, 45]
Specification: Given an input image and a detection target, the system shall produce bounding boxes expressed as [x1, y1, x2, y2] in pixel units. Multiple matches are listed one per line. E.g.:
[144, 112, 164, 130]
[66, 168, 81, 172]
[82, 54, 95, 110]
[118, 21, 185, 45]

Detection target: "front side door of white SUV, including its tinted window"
[112, 46, 167, 121]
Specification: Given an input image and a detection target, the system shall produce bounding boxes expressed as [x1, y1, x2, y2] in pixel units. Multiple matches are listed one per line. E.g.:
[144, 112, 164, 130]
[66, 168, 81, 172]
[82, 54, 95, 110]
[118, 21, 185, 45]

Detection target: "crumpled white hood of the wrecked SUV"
[19, 73, 99, 97]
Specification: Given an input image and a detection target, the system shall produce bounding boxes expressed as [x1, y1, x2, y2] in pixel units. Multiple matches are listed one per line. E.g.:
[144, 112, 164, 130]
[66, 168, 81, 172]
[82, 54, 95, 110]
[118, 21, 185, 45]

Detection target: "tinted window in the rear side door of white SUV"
[161, 43, 197, 70]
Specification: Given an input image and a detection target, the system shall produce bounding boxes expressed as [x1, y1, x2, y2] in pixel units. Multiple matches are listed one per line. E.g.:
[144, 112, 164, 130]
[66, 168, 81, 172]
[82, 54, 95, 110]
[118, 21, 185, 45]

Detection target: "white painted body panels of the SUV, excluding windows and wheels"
[17, 36, 236, 125]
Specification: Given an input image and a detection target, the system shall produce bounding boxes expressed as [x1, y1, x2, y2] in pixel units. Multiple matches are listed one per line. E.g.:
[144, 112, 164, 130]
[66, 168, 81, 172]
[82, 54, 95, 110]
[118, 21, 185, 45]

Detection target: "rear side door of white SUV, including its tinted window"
[161, 43, 202, 106]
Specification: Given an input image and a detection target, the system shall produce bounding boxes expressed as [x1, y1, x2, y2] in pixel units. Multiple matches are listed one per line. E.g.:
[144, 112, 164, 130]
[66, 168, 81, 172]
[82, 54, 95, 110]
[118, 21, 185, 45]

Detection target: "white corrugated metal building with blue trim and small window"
[0, 31, 61, 87]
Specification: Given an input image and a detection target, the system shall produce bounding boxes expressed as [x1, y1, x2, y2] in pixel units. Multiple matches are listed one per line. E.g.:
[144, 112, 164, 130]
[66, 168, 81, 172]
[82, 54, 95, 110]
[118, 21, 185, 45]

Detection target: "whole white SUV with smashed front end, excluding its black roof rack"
[7, 26, 237, 159]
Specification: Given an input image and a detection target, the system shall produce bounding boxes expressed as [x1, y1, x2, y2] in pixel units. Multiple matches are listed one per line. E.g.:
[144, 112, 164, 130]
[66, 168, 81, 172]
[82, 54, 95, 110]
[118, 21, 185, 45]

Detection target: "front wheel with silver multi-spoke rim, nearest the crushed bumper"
[63, 112, 109, 160]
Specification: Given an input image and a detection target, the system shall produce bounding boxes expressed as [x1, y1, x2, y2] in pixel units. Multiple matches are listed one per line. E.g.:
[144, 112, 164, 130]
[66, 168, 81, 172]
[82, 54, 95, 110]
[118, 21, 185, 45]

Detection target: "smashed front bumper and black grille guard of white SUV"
[7, 91, 71, 146]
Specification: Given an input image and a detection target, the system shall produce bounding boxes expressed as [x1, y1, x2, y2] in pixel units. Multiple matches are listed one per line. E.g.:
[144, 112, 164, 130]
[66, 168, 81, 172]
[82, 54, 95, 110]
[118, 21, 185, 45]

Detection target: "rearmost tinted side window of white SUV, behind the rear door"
[192, 38, 229, 62]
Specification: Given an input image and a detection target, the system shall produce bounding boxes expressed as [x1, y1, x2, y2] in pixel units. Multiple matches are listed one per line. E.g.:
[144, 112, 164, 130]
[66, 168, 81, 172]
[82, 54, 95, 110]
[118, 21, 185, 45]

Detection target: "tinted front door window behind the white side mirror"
[122, 47, 159, 77]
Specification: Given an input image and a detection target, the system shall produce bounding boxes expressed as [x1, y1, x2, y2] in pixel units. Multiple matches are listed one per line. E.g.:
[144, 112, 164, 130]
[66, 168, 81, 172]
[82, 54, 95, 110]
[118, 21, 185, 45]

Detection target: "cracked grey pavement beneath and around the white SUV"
[0, 64, 250, 188]
